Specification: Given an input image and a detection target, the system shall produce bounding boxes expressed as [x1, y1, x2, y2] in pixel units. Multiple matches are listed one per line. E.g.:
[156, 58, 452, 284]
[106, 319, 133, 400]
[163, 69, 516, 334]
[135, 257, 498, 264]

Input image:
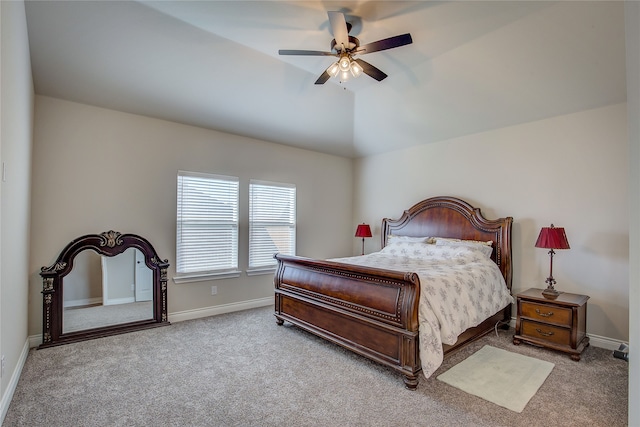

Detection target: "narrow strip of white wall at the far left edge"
[0, 1, 33, 420]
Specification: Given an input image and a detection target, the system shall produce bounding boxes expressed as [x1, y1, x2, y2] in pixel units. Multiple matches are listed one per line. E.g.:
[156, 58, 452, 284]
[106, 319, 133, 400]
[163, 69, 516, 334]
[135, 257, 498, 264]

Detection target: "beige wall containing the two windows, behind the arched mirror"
[29, 96, 355, 335]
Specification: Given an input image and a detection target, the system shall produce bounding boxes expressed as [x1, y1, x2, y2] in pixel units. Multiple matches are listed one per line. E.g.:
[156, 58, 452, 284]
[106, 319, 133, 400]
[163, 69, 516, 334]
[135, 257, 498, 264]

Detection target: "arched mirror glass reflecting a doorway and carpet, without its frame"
[62, 248, 153, 333]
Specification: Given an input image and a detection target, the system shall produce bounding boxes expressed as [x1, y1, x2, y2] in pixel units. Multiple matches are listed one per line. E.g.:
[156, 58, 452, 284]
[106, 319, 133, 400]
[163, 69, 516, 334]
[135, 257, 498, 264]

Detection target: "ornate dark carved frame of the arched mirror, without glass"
[39, 230, 169, 348]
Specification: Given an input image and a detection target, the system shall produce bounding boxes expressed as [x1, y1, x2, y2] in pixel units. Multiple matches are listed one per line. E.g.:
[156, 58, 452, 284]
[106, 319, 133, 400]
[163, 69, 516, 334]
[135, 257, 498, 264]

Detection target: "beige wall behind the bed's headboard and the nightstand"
[354, 104, 629, 341]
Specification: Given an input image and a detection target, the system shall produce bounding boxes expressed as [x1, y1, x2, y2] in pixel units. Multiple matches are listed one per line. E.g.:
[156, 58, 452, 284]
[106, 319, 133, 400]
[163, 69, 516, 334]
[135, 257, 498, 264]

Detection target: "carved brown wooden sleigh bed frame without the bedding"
[274, 197, 513, 389]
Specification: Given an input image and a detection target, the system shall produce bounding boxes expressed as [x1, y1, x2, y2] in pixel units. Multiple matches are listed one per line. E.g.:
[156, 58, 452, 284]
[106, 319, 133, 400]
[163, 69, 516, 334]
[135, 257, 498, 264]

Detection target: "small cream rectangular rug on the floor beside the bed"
[437, 345, 554, 413]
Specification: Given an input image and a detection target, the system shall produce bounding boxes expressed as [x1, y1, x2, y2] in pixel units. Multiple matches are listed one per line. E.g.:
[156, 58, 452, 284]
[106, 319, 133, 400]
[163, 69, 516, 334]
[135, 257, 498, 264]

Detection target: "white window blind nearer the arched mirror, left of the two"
[176, 171, 239, 274]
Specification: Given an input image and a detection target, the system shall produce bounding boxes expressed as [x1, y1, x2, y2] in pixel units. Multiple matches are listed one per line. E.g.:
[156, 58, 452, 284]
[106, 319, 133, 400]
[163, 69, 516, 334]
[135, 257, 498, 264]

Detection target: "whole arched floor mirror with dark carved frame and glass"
[40, 231, 169, 348]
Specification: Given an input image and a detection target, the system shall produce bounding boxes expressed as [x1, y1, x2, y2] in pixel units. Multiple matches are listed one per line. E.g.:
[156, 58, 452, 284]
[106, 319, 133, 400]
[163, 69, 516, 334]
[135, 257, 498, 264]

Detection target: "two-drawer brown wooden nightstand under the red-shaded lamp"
[513, 289, 589, 361]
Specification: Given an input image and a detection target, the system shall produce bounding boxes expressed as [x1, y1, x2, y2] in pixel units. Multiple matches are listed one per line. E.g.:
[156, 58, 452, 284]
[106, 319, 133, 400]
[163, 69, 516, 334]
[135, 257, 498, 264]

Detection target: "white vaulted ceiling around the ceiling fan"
[26, 0, 626, 157]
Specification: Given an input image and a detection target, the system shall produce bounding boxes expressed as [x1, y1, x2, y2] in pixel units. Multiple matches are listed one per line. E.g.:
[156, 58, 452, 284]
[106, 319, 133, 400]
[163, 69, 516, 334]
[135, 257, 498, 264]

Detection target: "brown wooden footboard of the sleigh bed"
[274, 254, 421, 388]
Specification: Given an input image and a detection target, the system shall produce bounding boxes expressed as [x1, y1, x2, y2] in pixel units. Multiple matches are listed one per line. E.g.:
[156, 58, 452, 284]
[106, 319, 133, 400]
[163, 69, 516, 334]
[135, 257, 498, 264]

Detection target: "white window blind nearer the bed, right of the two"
[249, 180, 296, 269]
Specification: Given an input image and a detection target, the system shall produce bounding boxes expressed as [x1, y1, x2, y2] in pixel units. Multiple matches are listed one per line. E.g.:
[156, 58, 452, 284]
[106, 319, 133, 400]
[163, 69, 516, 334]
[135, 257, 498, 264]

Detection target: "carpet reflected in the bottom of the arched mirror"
[62, 301, 153, 333]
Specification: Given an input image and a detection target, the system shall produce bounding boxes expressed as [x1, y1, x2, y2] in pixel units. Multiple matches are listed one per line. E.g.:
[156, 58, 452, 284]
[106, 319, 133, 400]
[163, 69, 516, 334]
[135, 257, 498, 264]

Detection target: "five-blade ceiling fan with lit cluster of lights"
[278, 12, 413, 85]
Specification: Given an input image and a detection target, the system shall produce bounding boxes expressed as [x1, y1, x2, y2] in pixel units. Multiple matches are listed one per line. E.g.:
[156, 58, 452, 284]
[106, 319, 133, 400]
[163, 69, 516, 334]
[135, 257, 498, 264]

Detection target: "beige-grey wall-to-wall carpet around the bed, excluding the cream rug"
[3, 307, 629, 427]
